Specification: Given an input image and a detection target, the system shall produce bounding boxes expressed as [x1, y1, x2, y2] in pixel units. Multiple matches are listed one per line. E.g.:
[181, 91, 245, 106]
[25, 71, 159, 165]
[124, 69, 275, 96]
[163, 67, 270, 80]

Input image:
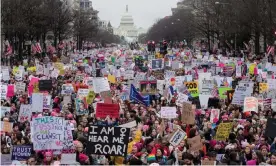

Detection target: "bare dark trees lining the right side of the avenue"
[144, 0, 276, 54]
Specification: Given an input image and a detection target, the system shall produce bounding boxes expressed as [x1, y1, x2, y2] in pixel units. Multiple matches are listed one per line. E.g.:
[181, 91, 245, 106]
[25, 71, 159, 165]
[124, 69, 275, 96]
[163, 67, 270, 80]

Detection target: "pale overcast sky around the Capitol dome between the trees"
[92, 0, 179, 28]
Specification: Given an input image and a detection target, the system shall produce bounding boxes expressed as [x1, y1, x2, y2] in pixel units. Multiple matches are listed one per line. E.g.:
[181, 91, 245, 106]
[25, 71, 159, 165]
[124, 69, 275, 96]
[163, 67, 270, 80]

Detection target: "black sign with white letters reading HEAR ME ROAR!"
[86, 126, 130, 156]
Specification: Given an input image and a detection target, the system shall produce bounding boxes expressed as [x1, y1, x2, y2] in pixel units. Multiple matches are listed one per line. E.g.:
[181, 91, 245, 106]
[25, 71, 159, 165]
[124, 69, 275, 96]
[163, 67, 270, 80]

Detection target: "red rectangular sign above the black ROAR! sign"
[96, 103, 120, 118]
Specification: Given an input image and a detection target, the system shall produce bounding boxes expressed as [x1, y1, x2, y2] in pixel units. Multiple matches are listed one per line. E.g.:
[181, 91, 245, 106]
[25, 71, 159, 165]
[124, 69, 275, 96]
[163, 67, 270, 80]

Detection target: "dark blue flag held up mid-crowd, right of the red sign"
[129, 84, 150, 106]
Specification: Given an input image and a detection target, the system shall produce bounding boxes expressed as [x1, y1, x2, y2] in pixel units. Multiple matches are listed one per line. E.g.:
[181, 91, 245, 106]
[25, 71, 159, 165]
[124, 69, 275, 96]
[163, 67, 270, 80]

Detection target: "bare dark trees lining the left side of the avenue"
[1, 0, 120, 54]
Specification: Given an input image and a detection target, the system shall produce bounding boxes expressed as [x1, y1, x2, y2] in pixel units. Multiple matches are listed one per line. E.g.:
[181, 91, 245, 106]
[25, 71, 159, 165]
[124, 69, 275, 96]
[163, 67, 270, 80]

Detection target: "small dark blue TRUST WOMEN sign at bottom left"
[11, 145, 33, 161]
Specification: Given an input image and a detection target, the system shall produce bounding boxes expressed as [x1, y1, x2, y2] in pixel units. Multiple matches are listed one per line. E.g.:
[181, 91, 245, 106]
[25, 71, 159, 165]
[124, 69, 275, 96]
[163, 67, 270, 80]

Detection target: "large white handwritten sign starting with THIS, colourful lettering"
[31, 116, 65, 150]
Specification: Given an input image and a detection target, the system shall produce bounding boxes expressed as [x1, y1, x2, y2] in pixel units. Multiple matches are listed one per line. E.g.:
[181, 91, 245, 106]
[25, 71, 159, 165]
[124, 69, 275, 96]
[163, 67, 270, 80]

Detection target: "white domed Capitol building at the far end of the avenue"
[113, 5, 147, 42]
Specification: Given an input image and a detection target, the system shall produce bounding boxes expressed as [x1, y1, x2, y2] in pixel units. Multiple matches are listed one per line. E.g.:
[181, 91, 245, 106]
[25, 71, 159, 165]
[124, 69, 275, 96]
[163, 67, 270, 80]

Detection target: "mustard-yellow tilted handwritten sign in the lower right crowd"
[215, 123, 232, 141]
